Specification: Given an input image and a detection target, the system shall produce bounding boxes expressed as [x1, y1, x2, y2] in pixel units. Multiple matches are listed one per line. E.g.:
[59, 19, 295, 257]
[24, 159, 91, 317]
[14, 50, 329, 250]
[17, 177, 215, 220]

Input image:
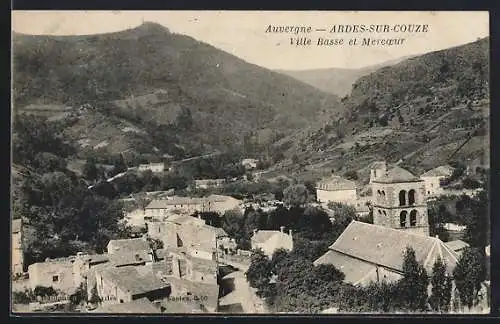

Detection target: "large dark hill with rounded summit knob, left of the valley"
[13, 23, 340, 161]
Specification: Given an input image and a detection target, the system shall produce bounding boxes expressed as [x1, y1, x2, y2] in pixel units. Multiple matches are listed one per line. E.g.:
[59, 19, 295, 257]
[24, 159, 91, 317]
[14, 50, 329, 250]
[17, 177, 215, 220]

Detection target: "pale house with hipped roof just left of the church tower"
[316, 175, 357, 204]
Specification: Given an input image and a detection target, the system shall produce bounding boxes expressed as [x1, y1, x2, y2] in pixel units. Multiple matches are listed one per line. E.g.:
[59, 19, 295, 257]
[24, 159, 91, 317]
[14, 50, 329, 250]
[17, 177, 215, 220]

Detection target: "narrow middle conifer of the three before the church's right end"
[429, 258, 452, 312]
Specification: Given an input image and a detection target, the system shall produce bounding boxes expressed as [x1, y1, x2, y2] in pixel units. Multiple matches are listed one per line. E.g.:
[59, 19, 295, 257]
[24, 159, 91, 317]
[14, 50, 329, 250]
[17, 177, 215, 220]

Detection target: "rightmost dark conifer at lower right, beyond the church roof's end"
[453, 248, 486, 308]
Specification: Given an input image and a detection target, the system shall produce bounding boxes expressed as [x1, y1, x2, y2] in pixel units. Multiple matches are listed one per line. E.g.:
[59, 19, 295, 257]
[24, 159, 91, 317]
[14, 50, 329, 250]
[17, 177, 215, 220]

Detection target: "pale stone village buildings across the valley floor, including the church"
[12, 159, 489, 314]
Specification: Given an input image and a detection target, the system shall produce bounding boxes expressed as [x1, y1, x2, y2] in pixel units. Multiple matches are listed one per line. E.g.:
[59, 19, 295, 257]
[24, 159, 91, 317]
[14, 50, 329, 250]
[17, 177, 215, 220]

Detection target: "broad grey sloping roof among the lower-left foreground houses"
[101, 266, 169, 295]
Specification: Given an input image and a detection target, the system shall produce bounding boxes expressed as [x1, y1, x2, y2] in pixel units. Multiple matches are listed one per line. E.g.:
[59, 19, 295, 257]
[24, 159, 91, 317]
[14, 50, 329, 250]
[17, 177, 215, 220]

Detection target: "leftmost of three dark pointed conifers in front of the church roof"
[399, 247, 429, 311]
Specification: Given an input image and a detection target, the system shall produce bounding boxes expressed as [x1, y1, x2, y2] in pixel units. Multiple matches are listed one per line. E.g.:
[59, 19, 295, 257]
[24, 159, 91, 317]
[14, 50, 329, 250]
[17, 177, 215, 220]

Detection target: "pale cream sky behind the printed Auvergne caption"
[12, 10, 489, 70]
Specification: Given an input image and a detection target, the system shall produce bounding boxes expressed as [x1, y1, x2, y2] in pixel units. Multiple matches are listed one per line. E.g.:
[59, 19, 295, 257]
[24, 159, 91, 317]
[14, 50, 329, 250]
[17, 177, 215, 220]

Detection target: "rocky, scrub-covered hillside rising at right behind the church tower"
[276, 38, 489, 181]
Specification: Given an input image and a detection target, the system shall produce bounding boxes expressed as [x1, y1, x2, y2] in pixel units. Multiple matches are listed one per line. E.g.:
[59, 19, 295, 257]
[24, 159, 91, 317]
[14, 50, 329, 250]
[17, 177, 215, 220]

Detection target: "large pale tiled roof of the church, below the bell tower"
[318, 221, 457, 276]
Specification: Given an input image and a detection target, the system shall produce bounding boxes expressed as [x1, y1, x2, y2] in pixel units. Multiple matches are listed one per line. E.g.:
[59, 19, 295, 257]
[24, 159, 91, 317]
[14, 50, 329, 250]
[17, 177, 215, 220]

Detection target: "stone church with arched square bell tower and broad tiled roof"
[314, 162, 458, 286]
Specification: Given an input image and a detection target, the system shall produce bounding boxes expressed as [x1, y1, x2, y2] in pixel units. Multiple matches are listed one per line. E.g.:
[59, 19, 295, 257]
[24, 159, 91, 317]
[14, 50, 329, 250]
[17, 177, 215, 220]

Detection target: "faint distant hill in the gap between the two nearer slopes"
[276, 57, 408, 97]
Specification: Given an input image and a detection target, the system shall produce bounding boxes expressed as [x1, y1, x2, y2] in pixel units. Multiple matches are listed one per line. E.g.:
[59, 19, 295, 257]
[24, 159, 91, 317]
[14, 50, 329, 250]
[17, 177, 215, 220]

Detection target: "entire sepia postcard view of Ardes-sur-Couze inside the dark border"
[9, 10, 491, 316]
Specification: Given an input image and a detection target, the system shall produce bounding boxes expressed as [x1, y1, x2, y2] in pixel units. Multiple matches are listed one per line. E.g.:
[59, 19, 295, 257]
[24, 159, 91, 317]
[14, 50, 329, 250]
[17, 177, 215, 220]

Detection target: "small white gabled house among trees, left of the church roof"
[250, 226, 293, 257]
